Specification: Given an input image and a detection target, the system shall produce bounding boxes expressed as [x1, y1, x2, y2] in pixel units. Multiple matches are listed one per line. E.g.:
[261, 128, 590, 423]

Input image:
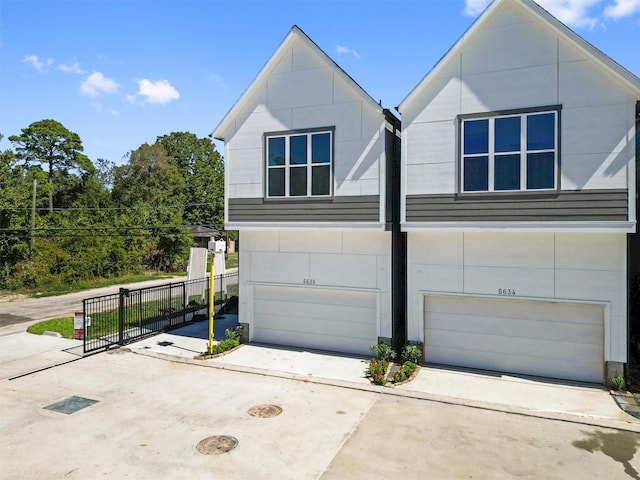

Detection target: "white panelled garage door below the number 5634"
[425, 296, 604, 383]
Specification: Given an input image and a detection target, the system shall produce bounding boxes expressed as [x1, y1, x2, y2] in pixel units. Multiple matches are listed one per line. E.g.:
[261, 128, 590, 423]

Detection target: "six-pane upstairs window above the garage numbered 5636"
[265, 129, 333, 198]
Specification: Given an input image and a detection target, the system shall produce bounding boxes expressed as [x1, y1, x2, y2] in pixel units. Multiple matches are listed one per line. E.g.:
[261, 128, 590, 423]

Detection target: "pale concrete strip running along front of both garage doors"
[127, 316, 640, 432]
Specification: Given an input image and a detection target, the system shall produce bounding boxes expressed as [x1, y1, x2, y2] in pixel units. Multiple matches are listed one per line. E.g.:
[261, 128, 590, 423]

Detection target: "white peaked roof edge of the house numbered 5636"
[211, 25, 382, 140]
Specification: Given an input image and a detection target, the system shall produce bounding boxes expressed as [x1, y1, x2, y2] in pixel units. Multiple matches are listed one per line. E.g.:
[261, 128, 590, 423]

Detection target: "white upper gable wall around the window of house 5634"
[401, 2, 638, 210]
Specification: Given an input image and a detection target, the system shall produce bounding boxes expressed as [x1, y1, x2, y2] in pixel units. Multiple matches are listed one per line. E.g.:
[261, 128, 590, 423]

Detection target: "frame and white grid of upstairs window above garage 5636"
[264, 127, 335, 199]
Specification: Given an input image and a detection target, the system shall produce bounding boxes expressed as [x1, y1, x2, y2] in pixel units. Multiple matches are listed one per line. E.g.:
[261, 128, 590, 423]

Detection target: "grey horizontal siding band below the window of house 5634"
[407, 189, 629, 222]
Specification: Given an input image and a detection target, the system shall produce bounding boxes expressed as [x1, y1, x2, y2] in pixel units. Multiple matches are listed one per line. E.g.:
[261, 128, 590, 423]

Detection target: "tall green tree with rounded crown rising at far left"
[9, 119, 94, 213]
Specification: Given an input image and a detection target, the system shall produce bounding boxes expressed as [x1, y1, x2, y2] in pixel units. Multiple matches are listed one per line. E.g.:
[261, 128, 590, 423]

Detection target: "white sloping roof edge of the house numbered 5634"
[397, 0, 640, 113]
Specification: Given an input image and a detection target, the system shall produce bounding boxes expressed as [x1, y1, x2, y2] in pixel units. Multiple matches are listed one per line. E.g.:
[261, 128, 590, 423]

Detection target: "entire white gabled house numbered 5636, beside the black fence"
[212, 26, 404, 354]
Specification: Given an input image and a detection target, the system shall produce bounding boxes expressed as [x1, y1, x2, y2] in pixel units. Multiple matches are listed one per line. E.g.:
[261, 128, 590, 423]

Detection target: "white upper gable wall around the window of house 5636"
[225, 39, 385, 198]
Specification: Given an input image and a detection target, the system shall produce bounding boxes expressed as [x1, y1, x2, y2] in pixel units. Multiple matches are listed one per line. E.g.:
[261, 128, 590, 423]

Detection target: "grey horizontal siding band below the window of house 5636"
[227, 195, 380, 222]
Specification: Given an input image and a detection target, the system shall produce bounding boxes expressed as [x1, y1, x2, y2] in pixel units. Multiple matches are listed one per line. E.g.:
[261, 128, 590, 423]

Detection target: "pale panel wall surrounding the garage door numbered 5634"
[407, 231, 627, 363]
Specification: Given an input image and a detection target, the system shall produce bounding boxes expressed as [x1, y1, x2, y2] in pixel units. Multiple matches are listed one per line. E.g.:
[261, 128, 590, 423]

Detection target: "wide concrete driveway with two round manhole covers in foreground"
[0, 349, 640, 480]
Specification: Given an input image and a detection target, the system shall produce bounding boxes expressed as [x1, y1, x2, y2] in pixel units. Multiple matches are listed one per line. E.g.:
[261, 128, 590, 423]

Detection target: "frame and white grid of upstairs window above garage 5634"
[457, 105, 562, 196]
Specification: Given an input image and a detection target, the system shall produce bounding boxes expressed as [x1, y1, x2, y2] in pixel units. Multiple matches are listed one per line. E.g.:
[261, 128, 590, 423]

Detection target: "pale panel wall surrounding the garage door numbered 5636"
[239, 230, 392, 344]
